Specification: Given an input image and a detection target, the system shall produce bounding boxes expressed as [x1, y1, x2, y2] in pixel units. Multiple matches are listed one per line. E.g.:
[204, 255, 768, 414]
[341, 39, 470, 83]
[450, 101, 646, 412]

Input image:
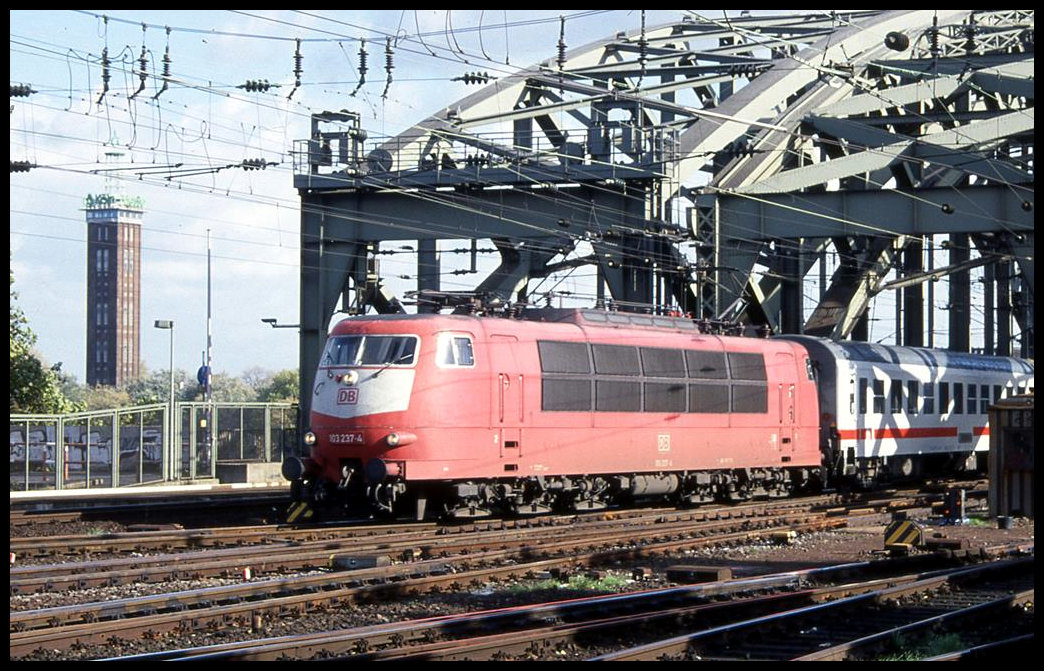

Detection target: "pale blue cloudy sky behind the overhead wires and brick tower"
[10, 9, 693, 382]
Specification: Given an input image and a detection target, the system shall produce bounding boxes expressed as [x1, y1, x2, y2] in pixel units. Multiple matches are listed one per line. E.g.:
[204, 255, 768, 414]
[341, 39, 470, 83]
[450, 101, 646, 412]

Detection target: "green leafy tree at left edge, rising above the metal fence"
[10, 270, 76, 413]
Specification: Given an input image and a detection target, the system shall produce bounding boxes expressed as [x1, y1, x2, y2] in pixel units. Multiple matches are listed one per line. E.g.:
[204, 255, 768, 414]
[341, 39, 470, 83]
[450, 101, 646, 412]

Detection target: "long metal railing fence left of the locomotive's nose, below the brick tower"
[10, 403, 298, 492]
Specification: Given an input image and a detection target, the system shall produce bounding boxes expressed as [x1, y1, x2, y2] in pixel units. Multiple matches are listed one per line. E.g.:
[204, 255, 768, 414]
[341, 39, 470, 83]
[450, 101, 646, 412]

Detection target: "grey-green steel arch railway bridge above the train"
[294, 10, 1034, 419]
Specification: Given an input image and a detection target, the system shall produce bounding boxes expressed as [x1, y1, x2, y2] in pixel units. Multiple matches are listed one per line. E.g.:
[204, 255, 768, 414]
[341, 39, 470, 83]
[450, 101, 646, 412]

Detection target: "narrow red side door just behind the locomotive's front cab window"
[490, 334, 525, 459]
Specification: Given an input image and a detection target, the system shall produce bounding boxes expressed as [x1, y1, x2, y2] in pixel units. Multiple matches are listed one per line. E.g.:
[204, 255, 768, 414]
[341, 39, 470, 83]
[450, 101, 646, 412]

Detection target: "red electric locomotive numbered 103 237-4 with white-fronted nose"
[284, 309, 822, 519]
